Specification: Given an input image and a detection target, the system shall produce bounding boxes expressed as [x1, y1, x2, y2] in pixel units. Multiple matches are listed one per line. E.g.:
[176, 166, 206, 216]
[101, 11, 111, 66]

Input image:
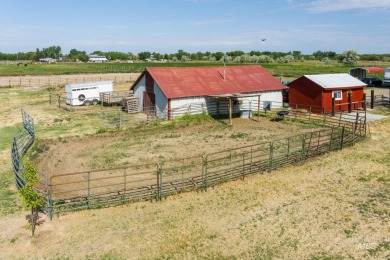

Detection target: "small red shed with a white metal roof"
[289, 73, 367, 113]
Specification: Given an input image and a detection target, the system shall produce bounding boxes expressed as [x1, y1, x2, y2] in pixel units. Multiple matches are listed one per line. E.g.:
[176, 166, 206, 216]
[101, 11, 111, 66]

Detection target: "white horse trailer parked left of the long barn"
[65, 81, 114, 106]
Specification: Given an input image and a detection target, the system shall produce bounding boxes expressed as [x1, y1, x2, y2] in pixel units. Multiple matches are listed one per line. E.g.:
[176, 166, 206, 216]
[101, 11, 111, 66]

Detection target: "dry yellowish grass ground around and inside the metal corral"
[0, 78, 390, 259]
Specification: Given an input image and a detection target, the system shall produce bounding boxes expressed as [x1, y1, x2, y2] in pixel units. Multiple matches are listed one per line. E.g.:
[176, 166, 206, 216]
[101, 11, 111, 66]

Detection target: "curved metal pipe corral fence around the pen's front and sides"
[12, 106, 366, 218]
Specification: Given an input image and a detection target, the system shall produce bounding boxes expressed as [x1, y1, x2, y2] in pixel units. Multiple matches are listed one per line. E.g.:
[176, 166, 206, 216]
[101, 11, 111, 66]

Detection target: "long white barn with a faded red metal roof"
[130, 65, 286, 120]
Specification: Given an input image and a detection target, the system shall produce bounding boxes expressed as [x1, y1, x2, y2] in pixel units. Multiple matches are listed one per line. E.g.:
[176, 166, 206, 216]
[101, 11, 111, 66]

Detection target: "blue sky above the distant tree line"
[0, 0, 390, 54]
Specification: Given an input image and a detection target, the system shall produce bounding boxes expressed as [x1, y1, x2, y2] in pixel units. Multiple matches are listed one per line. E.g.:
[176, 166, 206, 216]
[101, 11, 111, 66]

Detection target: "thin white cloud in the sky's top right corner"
[294, 0, 390, 13]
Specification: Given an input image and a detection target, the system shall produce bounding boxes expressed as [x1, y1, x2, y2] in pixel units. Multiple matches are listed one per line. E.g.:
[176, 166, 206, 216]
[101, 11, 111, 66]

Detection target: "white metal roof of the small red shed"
[303, 73, 367, 89]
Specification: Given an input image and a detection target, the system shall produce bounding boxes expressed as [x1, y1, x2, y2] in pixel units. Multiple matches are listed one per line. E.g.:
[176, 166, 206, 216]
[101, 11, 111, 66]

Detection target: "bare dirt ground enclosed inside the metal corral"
[31, 118, 310, 175]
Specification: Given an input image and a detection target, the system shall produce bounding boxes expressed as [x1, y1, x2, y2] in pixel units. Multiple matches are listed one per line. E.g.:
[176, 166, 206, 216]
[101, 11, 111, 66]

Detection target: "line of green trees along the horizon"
[0, 46, 390, 65]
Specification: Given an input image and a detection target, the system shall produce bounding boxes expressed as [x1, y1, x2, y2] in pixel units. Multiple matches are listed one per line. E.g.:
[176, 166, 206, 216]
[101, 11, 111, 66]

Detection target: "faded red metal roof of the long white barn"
[131, 65, 286, 98]
